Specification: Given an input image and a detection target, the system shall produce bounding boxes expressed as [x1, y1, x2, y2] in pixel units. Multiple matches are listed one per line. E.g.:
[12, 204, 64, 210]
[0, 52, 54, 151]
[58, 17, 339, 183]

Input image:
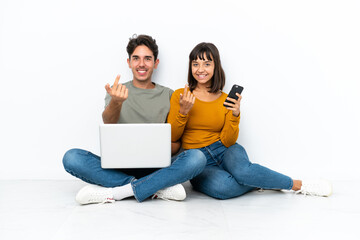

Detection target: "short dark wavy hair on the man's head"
[126, 34, 159, 61]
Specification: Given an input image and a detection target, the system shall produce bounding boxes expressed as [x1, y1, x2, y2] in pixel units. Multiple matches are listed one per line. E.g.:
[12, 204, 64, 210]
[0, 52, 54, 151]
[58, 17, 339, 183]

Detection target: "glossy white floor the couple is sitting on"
[0, 180, 360, 240]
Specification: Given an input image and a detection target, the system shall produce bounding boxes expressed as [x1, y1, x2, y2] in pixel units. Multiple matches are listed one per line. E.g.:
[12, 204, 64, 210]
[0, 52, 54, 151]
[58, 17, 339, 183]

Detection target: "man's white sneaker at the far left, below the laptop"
[75, 185, 115, 204]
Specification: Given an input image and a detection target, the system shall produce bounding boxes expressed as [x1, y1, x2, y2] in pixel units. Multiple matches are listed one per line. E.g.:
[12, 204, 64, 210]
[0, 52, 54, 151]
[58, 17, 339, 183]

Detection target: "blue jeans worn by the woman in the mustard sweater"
[190, 141, 293, 199]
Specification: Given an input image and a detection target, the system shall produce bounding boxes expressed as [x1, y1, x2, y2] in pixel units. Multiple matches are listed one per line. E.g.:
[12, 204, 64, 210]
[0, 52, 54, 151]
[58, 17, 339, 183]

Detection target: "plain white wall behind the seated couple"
[0, 0, 360, 179]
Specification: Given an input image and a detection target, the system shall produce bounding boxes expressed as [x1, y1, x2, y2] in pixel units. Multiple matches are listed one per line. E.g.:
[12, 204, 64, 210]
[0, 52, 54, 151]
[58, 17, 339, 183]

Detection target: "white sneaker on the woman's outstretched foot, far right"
[296, 179, 332, 197]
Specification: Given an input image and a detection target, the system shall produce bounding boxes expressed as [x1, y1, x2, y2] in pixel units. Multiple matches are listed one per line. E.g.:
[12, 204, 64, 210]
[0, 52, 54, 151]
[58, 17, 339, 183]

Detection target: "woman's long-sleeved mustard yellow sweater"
[168, 88, 240, 149]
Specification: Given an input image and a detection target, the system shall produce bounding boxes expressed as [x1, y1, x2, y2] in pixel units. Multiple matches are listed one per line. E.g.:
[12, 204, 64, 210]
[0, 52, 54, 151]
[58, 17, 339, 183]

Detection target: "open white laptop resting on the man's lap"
[100, 123, 171, 168]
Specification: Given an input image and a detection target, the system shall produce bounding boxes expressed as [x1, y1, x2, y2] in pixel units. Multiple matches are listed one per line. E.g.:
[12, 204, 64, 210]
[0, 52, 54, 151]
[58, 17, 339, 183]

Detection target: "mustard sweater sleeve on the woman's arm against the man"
[167, 89, 189, 142]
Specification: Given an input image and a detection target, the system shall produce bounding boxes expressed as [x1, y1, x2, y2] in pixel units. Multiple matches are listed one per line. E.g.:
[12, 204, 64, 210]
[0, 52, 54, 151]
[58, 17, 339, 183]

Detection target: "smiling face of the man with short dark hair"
[127, 45, 159, 82]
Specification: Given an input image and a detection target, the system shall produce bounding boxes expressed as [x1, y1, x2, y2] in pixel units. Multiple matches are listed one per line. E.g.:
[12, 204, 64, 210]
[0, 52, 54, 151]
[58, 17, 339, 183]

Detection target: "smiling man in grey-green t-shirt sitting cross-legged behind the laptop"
[63, 35, 206, 204]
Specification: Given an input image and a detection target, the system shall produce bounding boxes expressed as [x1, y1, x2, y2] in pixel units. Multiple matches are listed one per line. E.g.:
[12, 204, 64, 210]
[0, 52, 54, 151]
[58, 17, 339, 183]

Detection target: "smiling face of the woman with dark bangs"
[191, 56, 215, 85]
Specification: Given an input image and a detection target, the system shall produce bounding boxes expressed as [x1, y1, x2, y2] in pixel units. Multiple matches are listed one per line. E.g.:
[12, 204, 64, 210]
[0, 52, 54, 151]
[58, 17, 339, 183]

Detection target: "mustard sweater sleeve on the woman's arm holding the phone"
[220, 110, 240, 147]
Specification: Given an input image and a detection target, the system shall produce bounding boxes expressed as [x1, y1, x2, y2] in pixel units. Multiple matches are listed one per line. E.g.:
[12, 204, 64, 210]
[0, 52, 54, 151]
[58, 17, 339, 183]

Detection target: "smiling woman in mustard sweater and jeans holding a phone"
[168, 43, 332, 199]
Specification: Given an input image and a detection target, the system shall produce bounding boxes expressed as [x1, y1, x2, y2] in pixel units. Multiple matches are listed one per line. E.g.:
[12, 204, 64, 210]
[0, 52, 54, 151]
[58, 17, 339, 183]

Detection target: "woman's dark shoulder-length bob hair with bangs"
[188, 42, 225, 93]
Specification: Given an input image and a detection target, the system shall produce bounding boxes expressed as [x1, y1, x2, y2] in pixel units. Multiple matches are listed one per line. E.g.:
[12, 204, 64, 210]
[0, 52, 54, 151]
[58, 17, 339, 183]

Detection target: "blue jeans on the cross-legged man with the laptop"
[63, 149, 206, 202]
